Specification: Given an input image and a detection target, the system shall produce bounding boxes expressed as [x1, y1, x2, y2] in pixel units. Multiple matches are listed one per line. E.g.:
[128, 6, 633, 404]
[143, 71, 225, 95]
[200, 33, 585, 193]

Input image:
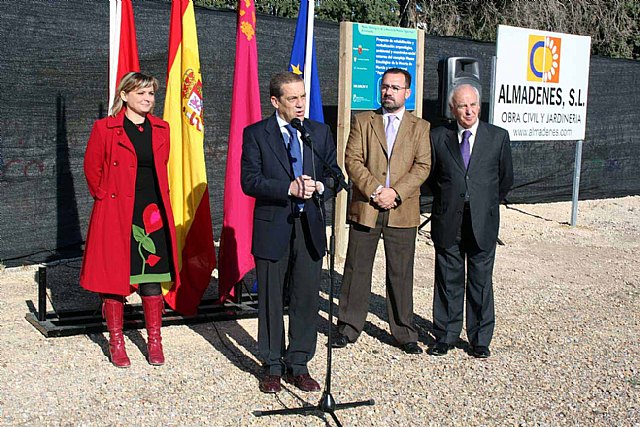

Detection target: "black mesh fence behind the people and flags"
[0, 0, 640, 265]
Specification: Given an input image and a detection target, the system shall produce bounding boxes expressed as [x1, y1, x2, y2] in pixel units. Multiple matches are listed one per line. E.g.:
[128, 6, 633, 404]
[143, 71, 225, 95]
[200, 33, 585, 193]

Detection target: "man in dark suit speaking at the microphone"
[241, 73, 340, 393]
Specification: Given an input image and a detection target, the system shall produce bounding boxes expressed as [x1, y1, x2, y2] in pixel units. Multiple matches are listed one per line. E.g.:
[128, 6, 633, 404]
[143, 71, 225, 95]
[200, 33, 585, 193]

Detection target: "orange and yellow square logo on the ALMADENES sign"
[527, 36, 562, 83]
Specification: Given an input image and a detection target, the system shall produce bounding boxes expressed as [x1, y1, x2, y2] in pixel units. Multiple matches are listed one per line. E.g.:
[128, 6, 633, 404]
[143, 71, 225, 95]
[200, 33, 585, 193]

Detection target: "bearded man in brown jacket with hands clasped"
[333, 68, 431, 354]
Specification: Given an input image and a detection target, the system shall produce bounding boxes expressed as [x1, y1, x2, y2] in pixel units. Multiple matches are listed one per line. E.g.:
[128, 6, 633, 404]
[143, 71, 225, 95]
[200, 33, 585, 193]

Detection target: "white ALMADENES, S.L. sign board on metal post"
[492, 25, 591, 141]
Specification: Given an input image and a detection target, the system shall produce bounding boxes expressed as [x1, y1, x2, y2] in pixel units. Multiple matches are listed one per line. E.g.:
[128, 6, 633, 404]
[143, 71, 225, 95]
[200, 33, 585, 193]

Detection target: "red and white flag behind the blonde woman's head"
[109, 0, 140, 112]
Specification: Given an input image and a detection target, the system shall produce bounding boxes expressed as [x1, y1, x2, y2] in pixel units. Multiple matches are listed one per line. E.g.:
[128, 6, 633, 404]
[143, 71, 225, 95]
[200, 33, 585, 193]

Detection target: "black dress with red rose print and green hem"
[124, 116, 172, 284]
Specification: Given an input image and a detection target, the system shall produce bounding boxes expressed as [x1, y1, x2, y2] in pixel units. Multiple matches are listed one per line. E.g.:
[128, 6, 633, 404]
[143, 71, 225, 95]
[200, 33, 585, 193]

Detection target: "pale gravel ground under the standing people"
[0, 196, 640, 426]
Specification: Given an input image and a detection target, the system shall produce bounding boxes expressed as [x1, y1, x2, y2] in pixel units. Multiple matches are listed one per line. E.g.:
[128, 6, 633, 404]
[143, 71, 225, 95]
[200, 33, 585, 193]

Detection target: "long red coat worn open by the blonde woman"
[80, 110, 180, 295]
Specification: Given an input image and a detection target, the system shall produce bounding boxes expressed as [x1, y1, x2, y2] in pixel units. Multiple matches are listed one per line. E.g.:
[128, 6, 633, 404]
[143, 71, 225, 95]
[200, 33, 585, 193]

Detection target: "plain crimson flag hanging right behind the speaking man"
[218, 0, 262, 302]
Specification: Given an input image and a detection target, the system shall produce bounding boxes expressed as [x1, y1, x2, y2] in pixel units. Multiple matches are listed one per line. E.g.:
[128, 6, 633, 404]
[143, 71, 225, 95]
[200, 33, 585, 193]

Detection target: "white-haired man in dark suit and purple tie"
[428, 84, 513, 358]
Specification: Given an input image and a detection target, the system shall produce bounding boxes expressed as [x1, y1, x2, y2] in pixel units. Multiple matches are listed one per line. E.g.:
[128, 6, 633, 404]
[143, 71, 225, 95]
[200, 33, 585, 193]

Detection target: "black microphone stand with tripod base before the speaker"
[253, 124, 375, 427]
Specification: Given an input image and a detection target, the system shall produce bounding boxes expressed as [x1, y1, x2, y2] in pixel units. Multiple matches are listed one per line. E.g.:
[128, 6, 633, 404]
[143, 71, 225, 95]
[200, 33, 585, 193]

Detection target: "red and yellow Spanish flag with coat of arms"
[163, 0, 216, 315]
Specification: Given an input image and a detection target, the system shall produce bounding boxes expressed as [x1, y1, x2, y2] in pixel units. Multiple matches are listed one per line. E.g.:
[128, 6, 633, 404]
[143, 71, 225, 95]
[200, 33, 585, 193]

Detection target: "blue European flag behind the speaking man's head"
[289, 0, 324, 123]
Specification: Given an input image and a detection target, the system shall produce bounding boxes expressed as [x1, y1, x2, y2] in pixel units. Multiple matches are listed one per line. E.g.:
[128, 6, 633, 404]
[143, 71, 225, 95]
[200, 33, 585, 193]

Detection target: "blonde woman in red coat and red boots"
[80, 72, 180, 367]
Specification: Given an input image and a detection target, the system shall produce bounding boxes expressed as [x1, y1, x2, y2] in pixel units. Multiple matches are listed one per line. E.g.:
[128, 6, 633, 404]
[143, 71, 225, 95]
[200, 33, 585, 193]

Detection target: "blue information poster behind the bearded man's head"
[351, 23, 418, 110]
